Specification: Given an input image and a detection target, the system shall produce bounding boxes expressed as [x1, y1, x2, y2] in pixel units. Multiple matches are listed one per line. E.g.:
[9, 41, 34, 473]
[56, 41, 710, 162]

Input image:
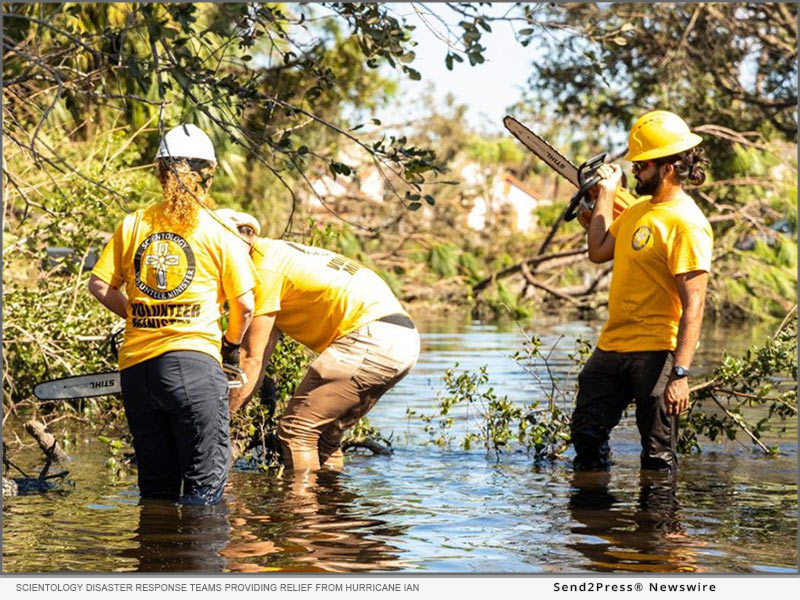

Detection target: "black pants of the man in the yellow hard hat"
[572, 348, 678, 470]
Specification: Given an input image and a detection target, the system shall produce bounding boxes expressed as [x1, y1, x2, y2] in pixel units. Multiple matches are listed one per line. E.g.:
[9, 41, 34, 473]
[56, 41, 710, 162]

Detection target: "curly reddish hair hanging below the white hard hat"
[152, 159, 216, 234]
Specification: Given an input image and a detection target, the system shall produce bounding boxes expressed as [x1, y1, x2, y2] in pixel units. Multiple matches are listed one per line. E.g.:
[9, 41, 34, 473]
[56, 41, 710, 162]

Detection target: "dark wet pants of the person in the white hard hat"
[120, 350, 231, 504]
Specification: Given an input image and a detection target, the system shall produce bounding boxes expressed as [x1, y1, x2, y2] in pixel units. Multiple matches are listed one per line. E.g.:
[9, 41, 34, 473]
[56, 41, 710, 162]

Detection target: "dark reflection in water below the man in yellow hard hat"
[568, 470, 703, 573]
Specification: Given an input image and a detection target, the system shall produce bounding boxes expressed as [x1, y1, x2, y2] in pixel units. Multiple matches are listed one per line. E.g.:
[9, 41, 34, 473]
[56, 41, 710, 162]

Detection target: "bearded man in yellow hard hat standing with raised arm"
[572, 110, 713, 470]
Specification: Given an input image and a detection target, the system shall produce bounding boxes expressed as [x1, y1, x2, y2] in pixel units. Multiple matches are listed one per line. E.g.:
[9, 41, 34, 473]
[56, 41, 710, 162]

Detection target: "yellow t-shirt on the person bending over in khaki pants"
[251, 238, 406, 352]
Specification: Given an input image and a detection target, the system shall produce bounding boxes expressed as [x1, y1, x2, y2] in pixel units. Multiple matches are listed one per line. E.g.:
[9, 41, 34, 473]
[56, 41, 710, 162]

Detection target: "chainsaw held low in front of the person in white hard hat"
[33, 328, 247, 400]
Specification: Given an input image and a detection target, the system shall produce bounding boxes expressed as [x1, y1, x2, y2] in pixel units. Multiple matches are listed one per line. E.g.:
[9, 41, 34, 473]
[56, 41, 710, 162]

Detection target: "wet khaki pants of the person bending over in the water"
[278, 321, 419, 471]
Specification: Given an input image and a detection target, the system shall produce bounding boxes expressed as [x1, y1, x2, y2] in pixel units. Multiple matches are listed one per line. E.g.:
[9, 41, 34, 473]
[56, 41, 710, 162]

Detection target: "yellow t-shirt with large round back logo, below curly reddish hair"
[92, 205, 257, 370]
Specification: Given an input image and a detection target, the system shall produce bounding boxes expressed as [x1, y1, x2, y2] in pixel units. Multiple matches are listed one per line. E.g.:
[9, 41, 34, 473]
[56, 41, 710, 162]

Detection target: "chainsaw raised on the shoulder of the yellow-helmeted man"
[503, 116, 638, 228]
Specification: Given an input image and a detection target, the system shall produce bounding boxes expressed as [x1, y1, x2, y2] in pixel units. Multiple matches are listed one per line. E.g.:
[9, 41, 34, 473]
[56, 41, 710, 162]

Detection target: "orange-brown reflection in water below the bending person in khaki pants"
[222, 471, 409, 572]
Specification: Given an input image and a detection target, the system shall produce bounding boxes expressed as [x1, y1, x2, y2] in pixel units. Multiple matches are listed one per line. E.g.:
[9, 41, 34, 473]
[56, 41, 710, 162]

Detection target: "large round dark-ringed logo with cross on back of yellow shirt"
[133, 231, 195, 300]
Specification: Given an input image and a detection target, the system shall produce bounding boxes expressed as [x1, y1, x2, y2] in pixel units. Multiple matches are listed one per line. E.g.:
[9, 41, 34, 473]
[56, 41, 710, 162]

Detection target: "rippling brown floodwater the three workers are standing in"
[3, 320, 797, 573]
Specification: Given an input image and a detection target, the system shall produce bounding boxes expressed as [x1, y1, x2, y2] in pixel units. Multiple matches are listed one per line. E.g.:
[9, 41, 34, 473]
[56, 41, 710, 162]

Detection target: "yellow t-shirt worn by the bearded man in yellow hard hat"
[597, 195, 713, 352]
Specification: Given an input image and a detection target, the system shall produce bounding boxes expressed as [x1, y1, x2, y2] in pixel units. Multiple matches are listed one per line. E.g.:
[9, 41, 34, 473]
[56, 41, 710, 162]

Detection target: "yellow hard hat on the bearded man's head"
[625, 110, 703, 161]
